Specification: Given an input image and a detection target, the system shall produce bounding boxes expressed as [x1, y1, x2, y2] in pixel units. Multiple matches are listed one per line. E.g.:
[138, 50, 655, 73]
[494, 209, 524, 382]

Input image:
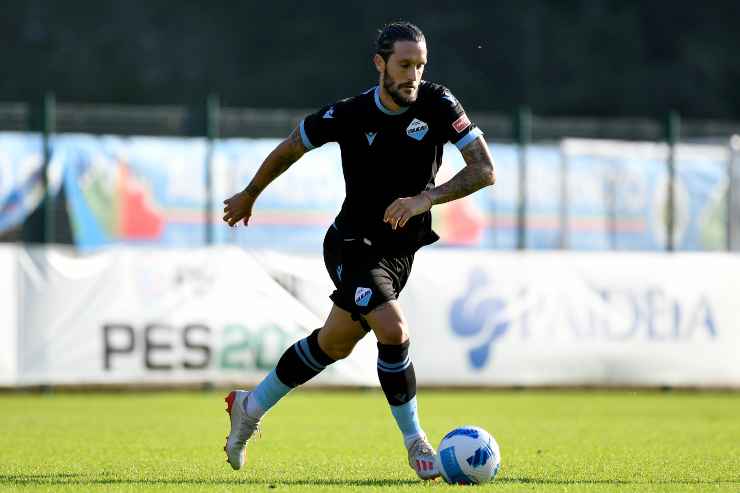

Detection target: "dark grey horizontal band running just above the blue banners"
[0, 95, 740, 141]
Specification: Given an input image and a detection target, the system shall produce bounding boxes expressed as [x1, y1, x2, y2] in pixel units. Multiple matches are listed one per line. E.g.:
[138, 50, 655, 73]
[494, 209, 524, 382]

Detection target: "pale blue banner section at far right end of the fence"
[564, 140, 729, 250]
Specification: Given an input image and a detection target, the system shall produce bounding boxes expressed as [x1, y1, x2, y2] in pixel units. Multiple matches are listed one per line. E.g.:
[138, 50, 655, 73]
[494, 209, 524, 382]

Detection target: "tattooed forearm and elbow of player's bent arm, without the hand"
[427, 137, 496, 204]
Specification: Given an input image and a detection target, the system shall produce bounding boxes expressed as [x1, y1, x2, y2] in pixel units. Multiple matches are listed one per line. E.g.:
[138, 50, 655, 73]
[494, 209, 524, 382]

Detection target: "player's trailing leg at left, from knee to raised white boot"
[224, 305, 367, 469]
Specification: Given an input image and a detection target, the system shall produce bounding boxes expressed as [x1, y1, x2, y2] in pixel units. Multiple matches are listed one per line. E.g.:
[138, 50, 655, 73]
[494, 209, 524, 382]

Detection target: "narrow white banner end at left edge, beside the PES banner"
[0, 245, 18, 386]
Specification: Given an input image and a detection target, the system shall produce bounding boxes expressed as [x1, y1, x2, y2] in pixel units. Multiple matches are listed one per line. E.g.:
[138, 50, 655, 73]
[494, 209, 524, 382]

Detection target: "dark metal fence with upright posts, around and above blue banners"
[0, 94, 740, 251]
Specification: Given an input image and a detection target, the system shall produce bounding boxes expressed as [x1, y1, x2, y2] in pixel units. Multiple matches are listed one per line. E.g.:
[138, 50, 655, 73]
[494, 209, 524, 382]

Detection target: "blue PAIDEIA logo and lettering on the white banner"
[450, 270, 720, 370]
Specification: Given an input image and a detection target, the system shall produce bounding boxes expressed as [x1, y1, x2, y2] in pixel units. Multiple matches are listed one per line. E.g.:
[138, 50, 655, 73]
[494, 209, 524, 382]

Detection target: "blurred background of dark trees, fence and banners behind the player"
[0, 0, 740, 386]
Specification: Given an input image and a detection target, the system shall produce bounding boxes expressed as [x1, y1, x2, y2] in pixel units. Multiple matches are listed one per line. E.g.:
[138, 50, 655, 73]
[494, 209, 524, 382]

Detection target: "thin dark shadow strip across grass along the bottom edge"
[0, 473, 740, 487]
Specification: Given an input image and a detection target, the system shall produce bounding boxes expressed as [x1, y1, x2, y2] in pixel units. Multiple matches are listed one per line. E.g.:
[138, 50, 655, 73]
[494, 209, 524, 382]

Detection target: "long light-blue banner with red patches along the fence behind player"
[0, 133, 727, 252]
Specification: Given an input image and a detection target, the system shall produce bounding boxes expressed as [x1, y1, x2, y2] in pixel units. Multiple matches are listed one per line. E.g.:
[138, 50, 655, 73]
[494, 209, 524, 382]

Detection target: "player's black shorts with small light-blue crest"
[324, 225, 414, 319]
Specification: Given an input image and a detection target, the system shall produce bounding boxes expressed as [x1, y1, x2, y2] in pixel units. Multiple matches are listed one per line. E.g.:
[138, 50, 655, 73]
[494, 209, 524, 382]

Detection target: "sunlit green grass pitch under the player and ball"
[0, 390, 740, 493]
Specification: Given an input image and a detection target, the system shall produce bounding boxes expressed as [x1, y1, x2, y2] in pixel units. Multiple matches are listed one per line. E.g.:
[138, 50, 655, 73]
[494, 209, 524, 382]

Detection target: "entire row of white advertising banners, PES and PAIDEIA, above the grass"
[7, 246, 740, 387]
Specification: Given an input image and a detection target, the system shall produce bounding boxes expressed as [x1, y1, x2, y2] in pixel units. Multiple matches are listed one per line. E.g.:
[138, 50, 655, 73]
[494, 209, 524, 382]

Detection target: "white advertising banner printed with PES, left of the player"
[18, 247, 377, 385]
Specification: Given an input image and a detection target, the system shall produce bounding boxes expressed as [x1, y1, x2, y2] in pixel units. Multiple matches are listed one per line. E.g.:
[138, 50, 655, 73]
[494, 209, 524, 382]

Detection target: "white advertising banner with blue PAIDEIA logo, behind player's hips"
[255, 248, 740, 387]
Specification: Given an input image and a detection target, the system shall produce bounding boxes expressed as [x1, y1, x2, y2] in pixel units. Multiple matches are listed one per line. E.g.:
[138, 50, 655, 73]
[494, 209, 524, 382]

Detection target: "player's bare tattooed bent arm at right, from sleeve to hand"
[384, 135, 496, 229]
